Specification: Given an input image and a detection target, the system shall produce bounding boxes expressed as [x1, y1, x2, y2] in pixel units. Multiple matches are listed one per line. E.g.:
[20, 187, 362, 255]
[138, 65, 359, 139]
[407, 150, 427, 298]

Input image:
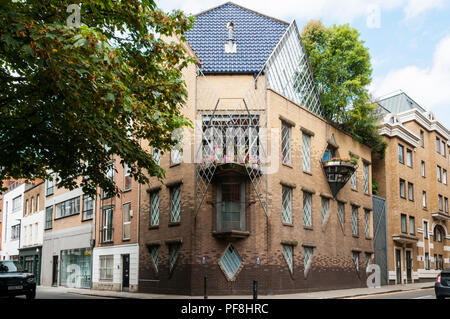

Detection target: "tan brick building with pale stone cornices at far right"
[373, 92, 450, 283]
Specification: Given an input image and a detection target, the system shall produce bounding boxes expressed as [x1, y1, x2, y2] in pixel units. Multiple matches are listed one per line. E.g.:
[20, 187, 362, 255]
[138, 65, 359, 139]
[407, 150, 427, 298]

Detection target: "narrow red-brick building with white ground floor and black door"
[93, 158, 141, 291]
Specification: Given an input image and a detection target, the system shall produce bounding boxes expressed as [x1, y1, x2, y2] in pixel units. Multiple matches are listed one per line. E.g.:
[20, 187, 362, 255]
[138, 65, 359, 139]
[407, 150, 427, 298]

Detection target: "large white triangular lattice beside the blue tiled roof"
[265, 21, 322, 116]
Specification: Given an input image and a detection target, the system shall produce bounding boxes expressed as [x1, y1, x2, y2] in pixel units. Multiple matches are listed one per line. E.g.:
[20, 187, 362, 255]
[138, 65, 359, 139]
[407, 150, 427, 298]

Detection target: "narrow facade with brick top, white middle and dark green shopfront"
[19, 182, 45, 285]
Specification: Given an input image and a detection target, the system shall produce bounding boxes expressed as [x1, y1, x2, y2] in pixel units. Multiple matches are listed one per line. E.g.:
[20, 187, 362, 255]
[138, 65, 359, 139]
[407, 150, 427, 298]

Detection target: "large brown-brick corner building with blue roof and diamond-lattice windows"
[139, 3, 373, 295]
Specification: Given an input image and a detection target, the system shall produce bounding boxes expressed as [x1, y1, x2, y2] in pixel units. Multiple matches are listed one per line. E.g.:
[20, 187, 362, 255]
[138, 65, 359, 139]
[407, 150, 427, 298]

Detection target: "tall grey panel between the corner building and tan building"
[372, 195, 389, 285]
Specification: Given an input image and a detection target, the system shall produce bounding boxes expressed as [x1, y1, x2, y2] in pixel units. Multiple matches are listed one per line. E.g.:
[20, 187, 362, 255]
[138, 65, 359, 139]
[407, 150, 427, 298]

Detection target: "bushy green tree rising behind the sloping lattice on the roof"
[302, 20, 386, 156]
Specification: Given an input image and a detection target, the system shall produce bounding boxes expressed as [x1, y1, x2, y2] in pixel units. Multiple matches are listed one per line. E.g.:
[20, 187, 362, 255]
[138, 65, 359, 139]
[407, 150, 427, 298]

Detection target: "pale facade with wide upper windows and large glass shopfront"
[41, 174, 96, 288]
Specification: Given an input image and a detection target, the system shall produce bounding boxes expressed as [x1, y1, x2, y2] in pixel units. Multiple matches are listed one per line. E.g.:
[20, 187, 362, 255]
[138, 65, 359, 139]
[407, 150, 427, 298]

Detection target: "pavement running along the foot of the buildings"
[38, 282, 434, 299]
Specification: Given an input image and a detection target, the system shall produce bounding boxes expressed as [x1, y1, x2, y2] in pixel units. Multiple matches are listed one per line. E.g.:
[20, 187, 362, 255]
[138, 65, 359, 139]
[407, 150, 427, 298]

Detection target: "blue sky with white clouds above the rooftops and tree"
[156, 0, 450, 129]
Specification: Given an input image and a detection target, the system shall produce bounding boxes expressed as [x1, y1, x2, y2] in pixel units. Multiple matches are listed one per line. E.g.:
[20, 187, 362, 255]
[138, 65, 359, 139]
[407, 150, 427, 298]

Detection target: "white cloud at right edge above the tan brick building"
[371, 35, 450, 111]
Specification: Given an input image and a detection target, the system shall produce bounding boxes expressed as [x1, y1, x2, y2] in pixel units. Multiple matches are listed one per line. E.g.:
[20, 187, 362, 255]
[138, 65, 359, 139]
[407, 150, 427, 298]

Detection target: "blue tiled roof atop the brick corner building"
[186, 2, 289, 74]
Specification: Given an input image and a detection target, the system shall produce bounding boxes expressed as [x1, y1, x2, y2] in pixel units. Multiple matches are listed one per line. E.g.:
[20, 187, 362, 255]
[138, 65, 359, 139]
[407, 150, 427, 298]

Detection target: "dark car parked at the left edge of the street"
[0, 260, 36, 299]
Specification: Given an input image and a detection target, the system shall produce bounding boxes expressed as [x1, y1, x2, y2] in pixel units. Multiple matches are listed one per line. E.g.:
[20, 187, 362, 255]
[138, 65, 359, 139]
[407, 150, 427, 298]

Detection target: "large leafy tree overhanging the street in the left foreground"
[0, 0, 193, 194]
